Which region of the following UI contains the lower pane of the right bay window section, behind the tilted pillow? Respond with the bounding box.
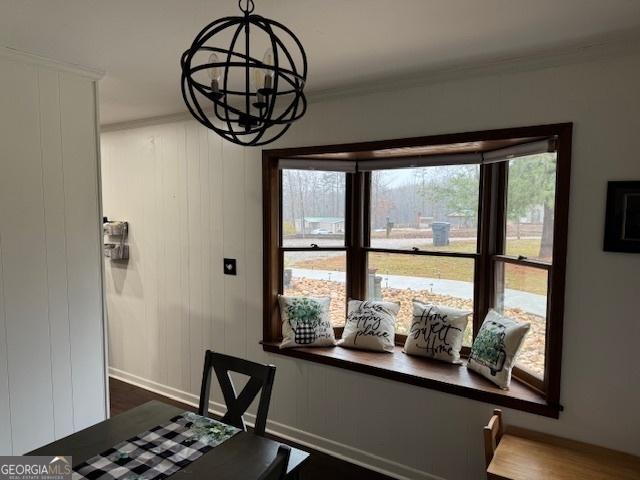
[494,262,548,379]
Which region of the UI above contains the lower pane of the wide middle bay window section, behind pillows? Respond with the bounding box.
[367,253,474,345]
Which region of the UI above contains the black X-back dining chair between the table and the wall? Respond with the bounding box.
[198,350,276,435]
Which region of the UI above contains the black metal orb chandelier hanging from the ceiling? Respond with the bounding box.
[180,0,307,146]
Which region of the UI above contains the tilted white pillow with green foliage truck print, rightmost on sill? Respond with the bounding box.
[467,310,530,390]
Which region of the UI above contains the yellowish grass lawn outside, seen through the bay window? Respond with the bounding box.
[287,240,547,295]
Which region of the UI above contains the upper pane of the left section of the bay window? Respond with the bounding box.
[282,170,346,247]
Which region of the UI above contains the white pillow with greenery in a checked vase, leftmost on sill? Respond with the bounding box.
[278,295,336,348]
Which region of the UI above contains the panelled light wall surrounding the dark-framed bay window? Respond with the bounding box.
[102,49,640,480]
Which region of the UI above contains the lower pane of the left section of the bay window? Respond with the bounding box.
[282,252,347,327]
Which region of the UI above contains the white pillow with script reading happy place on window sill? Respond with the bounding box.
[338,300,400,352]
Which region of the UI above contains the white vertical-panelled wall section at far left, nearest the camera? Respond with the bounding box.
[0,51,106,455]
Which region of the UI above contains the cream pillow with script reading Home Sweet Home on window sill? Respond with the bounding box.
[404,300,471,363]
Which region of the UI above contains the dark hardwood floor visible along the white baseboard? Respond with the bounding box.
[109,378,391,480]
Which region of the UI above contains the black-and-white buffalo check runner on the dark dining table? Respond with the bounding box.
[73,412,240,480]
